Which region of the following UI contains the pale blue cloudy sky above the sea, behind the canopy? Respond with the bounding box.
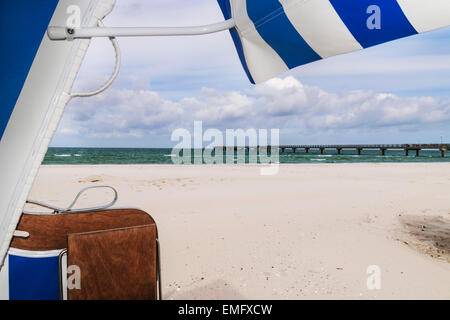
[51,0,450,148]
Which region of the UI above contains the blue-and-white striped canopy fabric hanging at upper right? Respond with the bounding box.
[218,0,450,83]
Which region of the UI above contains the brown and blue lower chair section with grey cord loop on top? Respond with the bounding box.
[6,186,161,300]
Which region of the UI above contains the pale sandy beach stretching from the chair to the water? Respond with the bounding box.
[29,163,450,299]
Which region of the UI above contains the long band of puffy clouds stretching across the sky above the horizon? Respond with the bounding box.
[58,77,450,144]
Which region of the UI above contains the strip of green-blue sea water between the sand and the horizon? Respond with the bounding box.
[43,148,450,165]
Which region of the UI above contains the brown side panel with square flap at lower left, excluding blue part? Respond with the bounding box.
[11,209,161,300]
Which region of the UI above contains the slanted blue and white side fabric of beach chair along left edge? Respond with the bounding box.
[0,0,115,270]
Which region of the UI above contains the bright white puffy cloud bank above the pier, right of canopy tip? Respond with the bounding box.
[250,77,450,130]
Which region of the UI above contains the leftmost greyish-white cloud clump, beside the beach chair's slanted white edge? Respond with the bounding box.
[61,89,185,137]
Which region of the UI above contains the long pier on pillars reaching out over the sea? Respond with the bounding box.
[215,144,450,157]
